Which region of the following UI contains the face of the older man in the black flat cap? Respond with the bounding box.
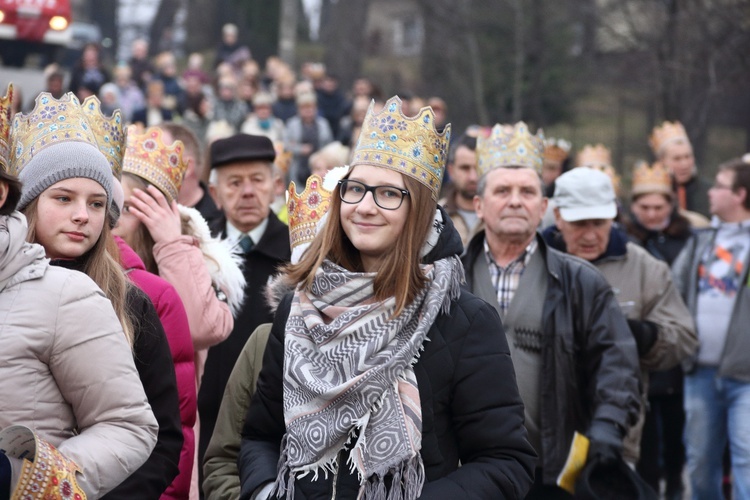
[210,161,274,233]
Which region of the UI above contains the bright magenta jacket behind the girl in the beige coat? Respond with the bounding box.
[115,237,197,499]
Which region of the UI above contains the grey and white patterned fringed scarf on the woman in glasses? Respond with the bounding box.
[276,257,463,500]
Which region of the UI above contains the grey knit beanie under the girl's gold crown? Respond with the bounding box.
[18,141,113,210]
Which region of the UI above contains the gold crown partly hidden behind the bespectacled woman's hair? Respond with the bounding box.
[286,175,332,251]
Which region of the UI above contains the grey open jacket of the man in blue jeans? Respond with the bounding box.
[672,228,750,382]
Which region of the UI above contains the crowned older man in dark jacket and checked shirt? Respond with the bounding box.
[462,122,640,500]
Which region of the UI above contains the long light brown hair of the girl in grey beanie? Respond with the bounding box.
[23,196,135,348]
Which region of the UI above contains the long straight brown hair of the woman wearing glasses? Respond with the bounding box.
[284,167,436,315]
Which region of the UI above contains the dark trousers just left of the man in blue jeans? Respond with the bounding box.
[636,393,685,493]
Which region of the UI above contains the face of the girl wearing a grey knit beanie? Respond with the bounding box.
[34,177,107,259]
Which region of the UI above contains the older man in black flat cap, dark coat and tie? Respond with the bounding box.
[198,134,291,480]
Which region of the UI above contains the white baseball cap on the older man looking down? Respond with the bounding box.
[552,167,617,222]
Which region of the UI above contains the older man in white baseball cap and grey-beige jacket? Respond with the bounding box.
[543,167,698,472]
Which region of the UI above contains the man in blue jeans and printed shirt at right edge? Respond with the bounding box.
[672,154,750,498]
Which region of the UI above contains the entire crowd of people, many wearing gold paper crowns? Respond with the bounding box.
[0,30,750,500]
